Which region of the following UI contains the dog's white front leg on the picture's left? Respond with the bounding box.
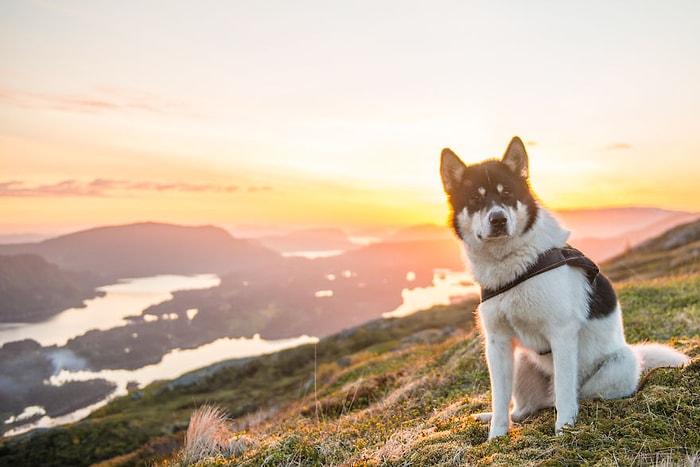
[486,335,513,439]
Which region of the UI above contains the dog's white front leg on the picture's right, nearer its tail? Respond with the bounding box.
[551,331,578,434]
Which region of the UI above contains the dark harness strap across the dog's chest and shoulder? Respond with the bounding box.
[481,245,600,302]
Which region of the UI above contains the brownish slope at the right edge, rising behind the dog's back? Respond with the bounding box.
[601,220,700,281]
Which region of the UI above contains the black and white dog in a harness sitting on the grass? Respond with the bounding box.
[440,136,690,439]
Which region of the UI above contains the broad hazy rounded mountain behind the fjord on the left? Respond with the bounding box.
[0,222,279,282]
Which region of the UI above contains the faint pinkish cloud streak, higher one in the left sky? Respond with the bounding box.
[0,87,200,116]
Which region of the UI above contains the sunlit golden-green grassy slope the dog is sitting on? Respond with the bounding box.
[164,276,700,466]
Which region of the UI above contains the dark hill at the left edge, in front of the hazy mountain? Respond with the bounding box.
[0,254,100,323]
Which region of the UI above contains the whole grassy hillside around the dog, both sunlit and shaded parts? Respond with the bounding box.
[0,275,700,466]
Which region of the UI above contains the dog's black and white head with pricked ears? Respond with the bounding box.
[440,136,537,244]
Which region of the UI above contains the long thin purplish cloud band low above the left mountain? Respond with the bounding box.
[0,178,272,198]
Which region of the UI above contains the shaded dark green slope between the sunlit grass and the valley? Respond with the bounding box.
[0,305,473,466]
